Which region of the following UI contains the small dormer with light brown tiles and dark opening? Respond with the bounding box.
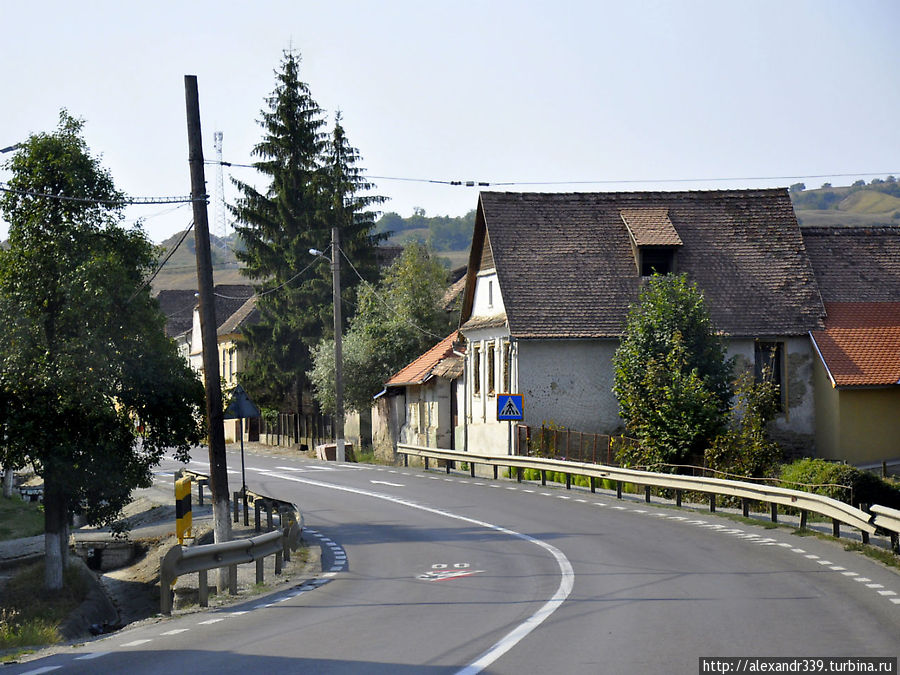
[619,206,683,277]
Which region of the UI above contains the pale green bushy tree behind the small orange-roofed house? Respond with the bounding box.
[309,243,455,412]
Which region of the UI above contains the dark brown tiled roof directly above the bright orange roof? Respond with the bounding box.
[800,226,900,302]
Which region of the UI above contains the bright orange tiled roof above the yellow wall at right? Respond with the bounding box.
[812,302,900,387]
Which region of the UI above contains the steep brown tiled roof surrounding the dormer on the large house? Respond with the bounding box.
[461,189,824,338]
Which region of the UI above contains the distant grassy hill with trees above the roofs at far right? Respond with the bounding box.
[790,176,900,227]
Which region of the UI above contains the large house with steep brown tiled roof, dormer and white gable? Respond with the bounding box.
[460,189,825,454]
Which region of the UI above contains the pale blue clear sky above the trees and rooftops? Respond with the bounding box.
[0,0,900,242]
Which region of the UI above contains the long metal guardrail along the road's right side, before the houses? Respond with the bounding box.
[397,443,900,551]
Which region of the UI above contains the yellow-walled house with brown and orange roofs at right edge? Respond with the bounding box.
[803,226,900,465]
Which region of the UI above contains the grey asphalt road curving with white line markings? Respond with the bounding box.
[8,452,900,675]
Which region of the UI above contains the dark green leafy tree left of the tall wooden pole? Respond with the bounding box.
[0,111,203,588]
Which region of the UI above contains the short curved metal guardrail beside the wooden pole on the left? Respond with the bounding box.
[159,470,303,614]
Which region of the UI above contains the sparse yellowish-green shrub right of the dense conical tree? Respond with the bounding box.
[704,372,781,478]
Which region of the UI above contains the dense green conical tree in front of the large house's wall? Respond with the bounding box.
[613,275,733,466]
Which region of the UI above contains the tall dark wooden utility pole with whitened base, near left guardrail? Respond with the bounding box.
[184,75,231,593]
